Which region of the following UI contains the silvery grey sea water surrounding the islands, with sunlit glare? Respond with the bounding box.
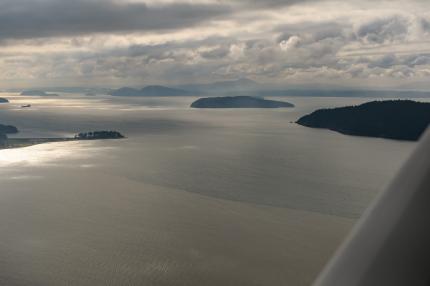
[0,94,424,285]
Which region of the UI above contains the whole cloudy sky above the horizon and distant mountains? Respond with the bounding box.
[0,0,430,90]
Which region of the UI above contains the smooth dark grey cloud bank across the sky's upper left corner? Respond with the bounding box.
[0,0,231,39]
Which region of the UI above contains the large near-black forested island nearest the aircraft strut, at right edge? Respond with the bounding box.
[297,100,430,141]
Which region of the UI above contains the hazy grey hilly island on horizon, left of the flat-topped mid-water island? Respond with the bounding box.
[110,85,191,96]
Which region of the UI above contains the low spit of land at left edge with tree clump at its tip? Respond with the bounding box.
[0,127,125,149]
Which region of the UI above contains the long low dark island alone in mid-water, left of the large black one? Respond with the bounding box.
[191,96,294,108]
